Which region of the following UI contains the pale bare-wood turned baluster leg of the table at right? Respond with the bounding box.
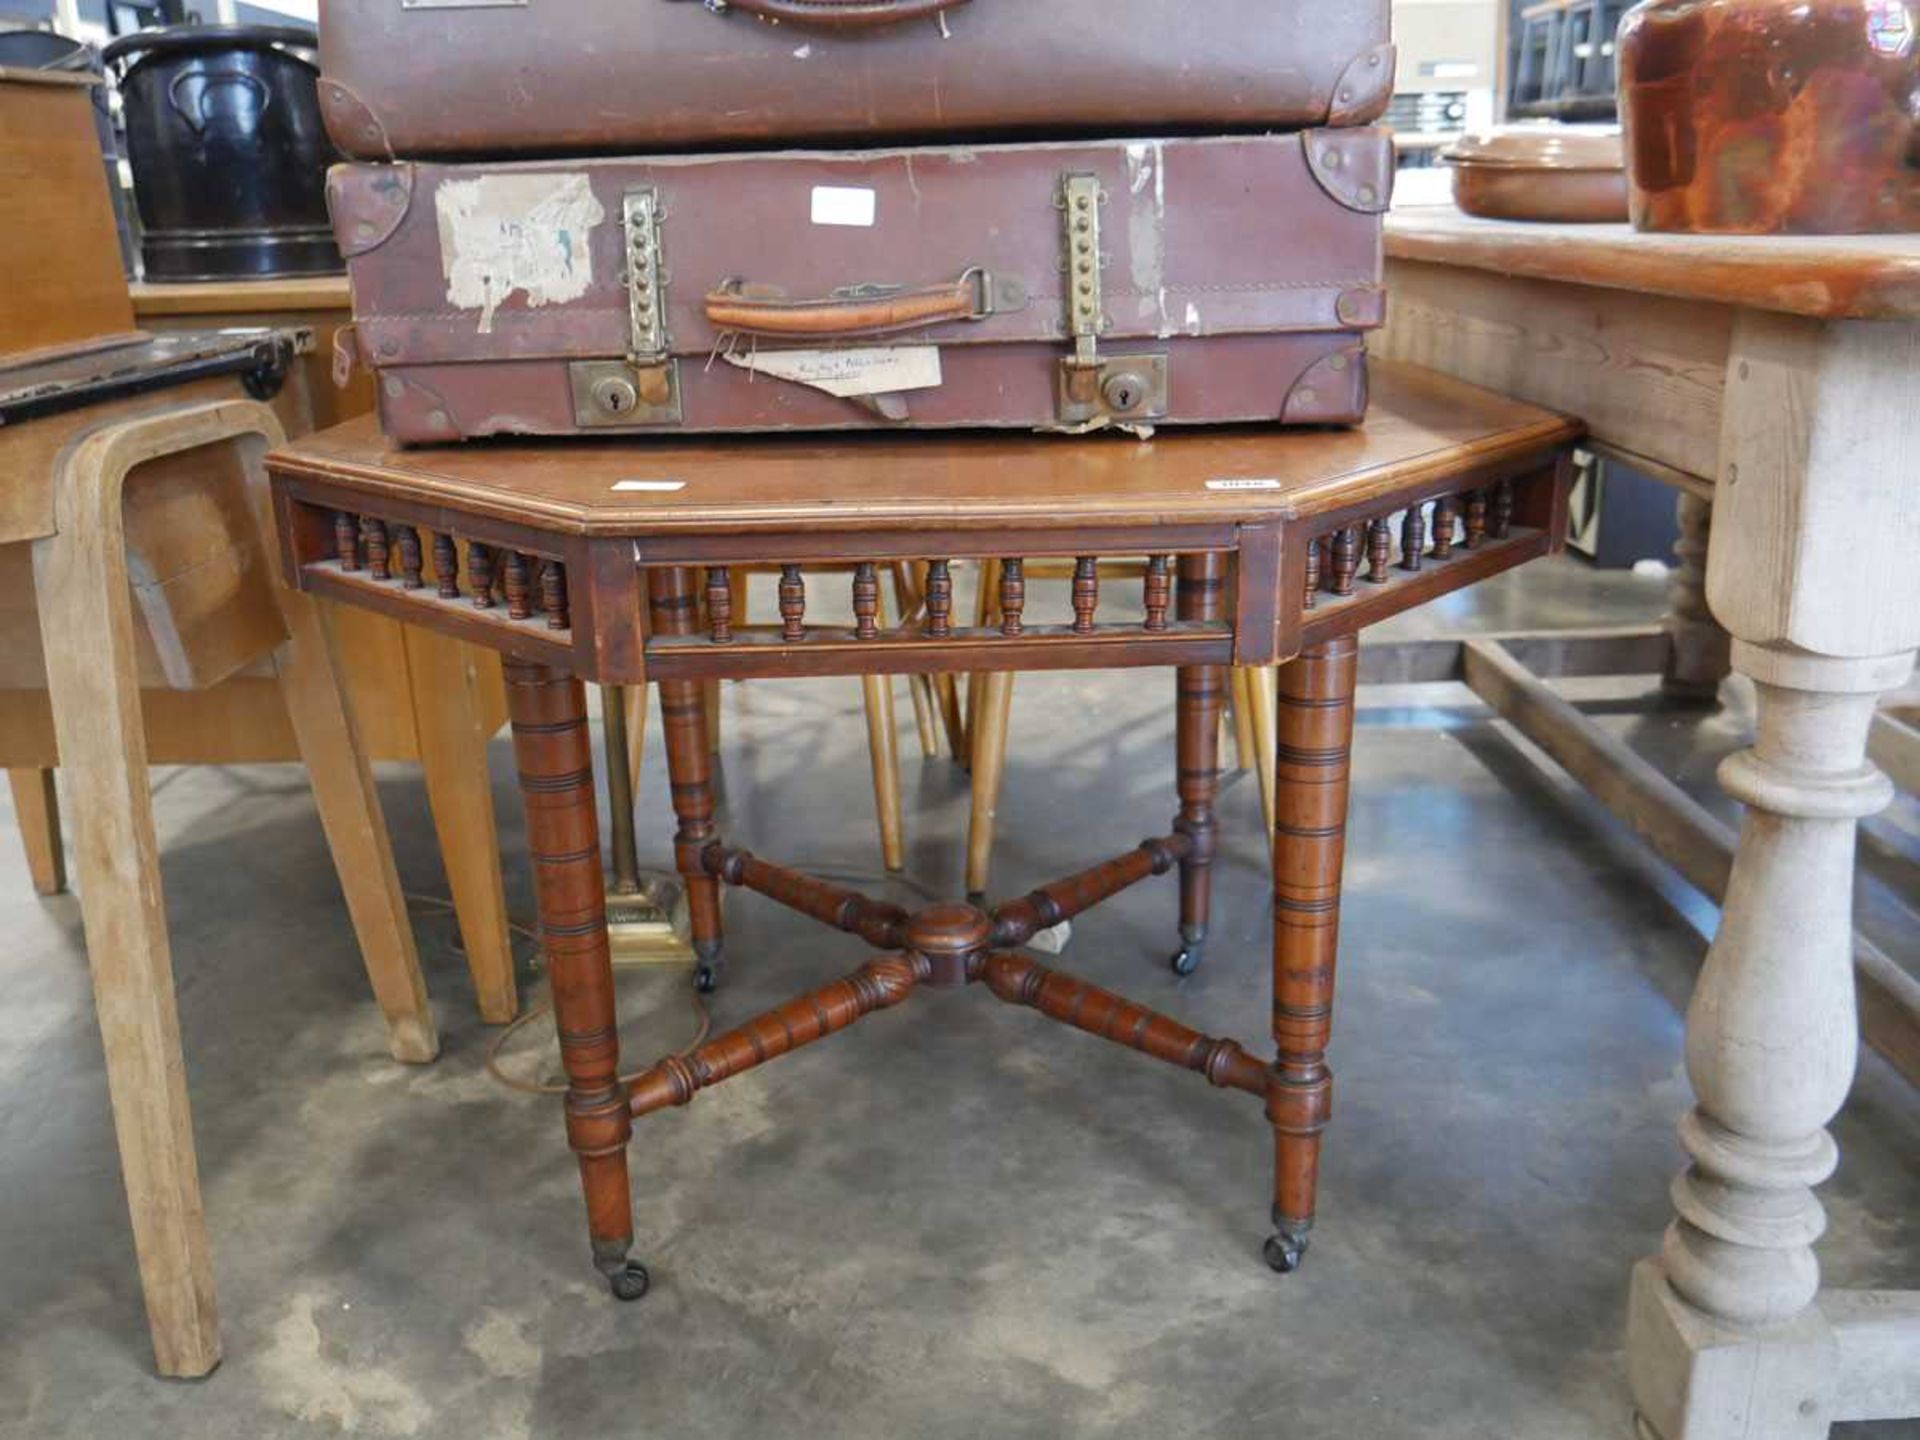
[1626,313,1920,1440]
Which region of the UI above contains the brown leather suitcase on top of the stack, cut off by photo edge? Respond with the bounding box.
[321,0,1394,159]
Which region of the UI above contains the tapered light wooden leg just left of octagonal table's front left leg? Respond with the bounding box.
[405,626,520,1025]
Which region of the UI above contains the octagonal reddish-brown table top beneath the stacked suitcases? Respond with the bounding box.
[269,363,1580,536]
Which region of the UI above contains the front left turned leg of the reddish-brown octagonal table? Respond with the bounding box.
[507,660,648,1300]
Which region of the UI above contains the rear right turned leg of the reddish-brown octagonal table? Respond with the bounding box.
[1171,555,1229,975]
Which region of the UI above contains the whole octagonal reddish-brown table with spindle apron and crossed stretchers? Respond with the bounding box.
[271,366,1578,1298]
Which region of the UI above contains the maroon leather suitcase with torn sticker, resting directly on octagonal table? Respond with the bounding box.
[328,129,1394,442]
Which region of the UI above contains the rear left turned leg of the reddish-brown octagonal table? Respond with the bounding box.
[651,570,722,991]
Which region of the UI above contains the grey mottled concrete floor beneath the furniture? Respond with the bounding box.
[0,561,1920,1440]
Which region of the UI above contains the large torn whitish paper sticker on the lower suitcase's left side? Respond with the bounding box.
[434,175,607,334]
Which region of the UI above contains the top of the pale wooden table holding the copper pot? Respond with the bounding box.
[1386,204,1920,321]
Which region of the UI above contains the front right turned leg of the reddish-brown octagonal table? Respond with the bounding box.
[1267,637,1359,1273]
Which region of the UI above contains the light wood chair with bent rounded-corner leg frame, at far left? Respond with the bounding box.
[0,399,440,1377]
